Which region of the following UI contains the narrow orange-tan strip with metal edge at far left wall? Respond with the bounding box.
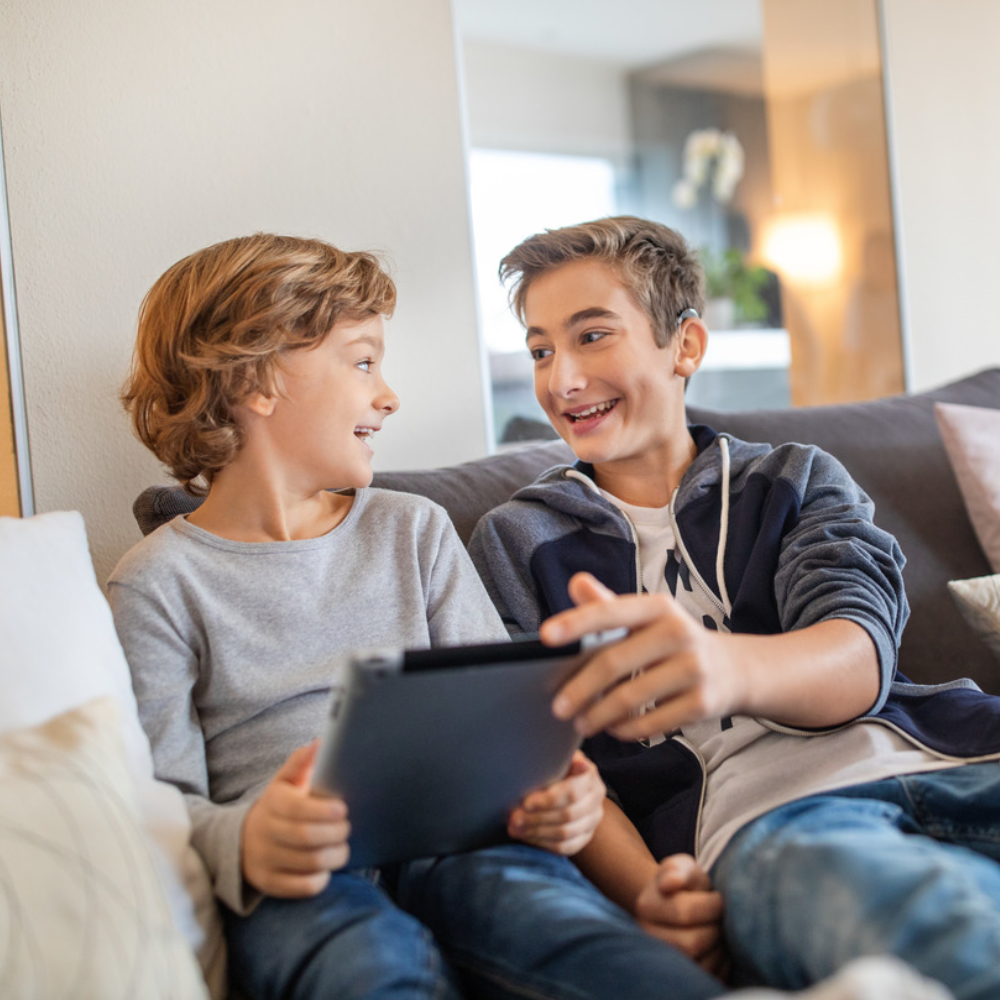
[0,119,34,517]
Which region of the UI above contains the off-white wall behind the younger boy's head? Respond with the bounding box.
[0,0,486,580]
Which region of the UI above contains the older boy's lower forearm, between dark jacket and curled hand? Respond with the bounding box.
[573,799,657,914]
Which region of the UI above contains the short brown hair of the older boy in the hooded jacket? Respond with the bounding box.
[500,215,705,347]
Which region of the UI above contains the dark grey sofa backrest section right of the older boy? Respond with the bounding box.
[690,368,1000,694]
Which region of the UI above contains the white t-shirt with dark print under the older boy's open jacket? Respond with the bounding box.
[601,490,961,868]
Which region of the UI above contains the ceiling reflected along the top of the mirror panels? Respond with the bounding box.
[452,0,881,96]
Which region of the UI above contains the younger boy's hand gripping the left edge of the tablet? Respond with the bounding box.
[242,741,351,899]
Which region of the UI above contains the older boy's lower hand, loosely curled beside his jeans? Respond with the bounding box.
[635,854,729,978]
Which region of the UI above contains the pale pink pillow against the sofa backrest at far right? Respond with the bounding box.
[928,403,1000,573]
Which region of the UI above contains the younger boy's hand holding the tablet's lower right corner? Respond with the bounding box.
[507,750,605,857]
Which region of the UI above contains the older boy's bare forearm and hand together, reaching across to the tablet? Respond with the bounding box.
[541,573,881,740]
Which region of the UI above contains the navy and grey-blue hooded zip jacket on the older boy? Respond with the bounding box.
[469,426,1000,858]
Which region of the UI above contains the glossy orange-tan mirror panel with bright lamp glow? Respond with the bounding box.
[757,0,904,405]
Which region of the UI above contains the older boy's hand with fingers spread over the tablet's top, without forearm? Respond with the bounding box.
[540,573,743,740]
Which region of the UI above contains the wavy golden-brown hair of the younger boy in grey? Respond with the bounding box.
[121,233,396,494]
